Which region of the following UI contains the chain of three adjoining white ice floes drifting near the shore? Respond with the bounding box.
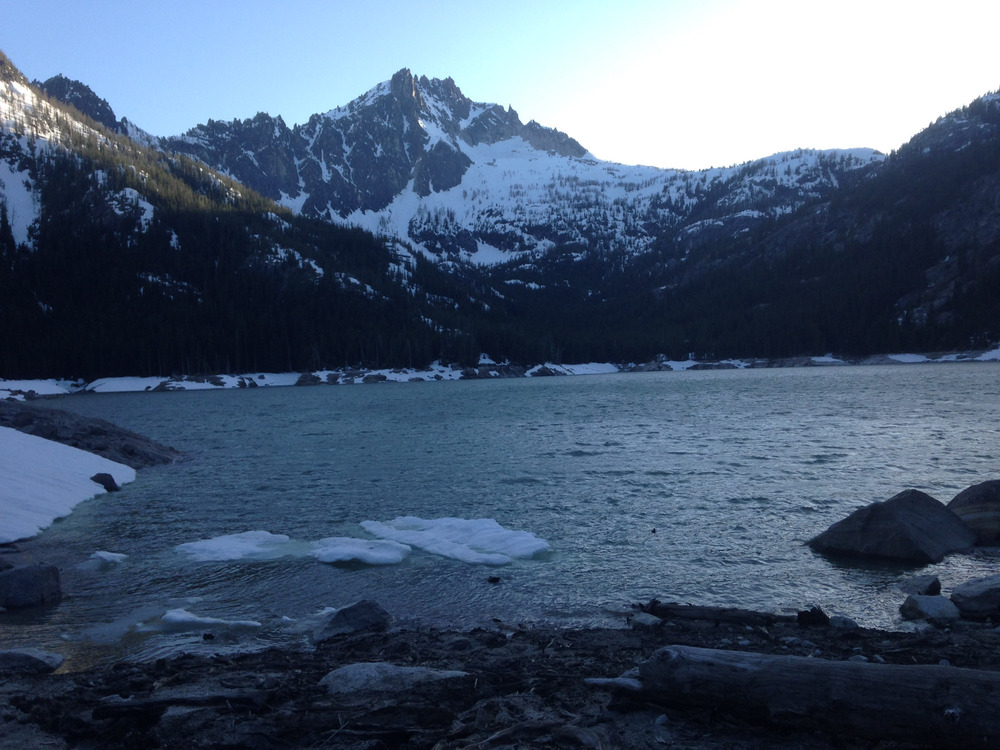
[176,516,549,565]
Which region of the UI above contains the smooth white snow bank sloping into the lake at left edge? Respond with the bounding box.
[0,427,135,544]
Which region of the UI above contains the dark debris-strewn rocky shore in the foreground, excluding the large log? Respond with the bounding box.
[0,602,1000,750]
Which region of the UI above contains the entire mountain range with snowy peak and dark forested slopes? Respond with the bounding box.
[0,51,1000,377]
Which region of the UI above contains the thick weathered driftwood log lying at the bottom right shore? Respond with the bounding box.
[639,646,1000,748]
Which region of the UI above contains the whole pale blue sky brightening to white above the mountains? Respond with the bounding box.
[0,0,1000,169]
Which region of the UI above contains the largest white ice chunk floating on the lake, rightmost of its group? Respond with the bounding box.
[361,516,549,565]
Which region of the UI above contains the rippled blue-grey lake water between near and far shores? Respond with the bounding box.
[7,364,1000,665]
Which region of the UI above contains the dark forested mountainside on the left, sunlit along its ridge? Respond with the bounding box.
[0,51,480,378]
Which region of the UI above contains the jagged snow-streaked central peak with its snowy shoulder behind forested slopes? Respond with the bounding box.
[163,69,883,264]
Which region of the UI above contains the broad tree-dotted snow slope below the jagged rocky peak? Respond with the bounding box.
[344,138,882,264]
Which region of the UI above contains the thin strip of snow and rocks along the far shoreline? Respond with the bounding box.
[0,347,1000,400]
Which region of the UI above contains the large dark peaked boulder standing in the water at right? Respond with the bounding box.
[809,490,976,564]
